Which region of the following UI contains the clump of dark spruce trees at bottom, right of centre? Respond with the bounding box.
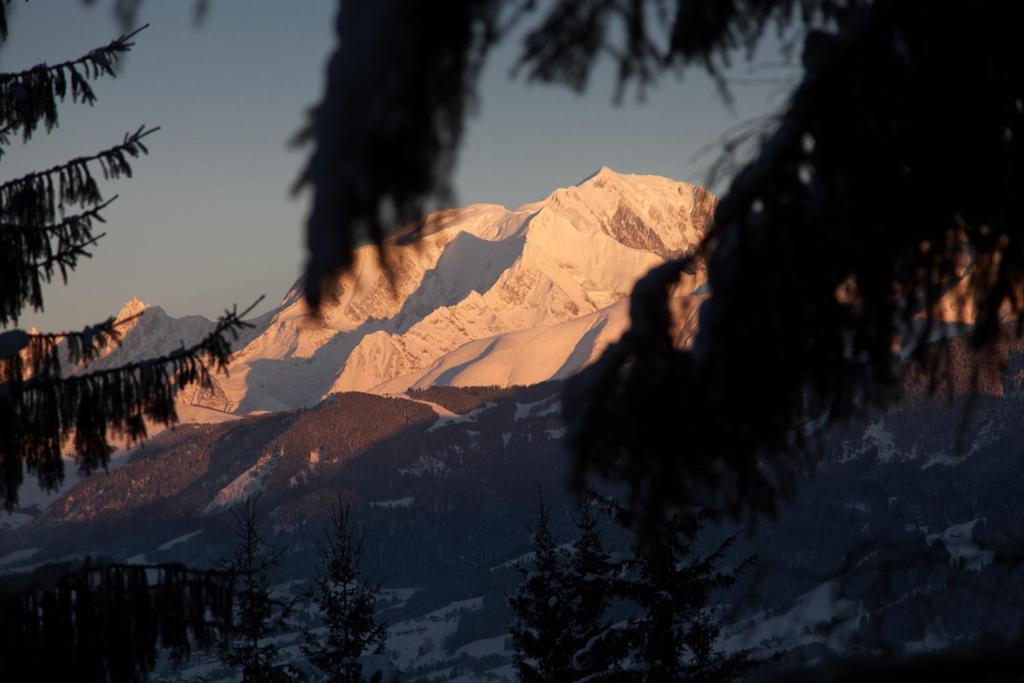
[509,494,754,683]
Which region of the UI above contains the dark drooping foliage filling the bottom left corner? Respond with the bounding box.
[0,562,234,682]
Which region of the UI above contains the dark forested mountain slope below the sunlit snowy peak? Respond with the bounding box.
[0,385,1024,680]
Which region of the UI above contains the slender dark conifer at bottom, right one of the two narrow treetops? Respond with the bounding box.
[302,501,387,683]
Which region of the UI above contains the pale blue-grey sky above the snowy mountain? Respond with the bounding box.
[0,0,781,330]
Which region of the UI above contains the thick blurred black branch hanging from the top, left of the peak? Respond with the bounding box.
[296,0,503,309]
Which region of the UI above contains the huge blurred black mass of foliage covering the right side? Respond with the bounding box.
[567,2,1024,524]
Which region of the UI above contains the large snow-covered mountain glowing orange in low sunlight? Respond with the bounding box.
[192,168,715,413]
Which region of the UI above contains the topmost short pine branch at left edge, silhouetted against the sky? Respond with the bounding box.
[0,24,148,140]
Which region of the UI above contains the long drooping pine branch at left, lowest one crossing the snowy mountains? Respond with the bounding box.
[0,297,262,509]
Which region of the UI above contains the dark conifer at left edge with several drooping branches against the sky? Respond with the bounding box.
[0,12,256,510]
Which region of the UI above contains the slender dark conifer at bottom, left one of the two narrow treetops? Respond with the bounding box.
[218,500,302,683]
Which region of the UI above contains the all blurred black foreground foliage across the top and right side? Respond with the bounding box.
[292,0,1024,519]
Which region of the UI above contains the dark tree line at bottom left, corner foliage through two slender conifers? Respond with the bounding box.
[0,500,397,683]
